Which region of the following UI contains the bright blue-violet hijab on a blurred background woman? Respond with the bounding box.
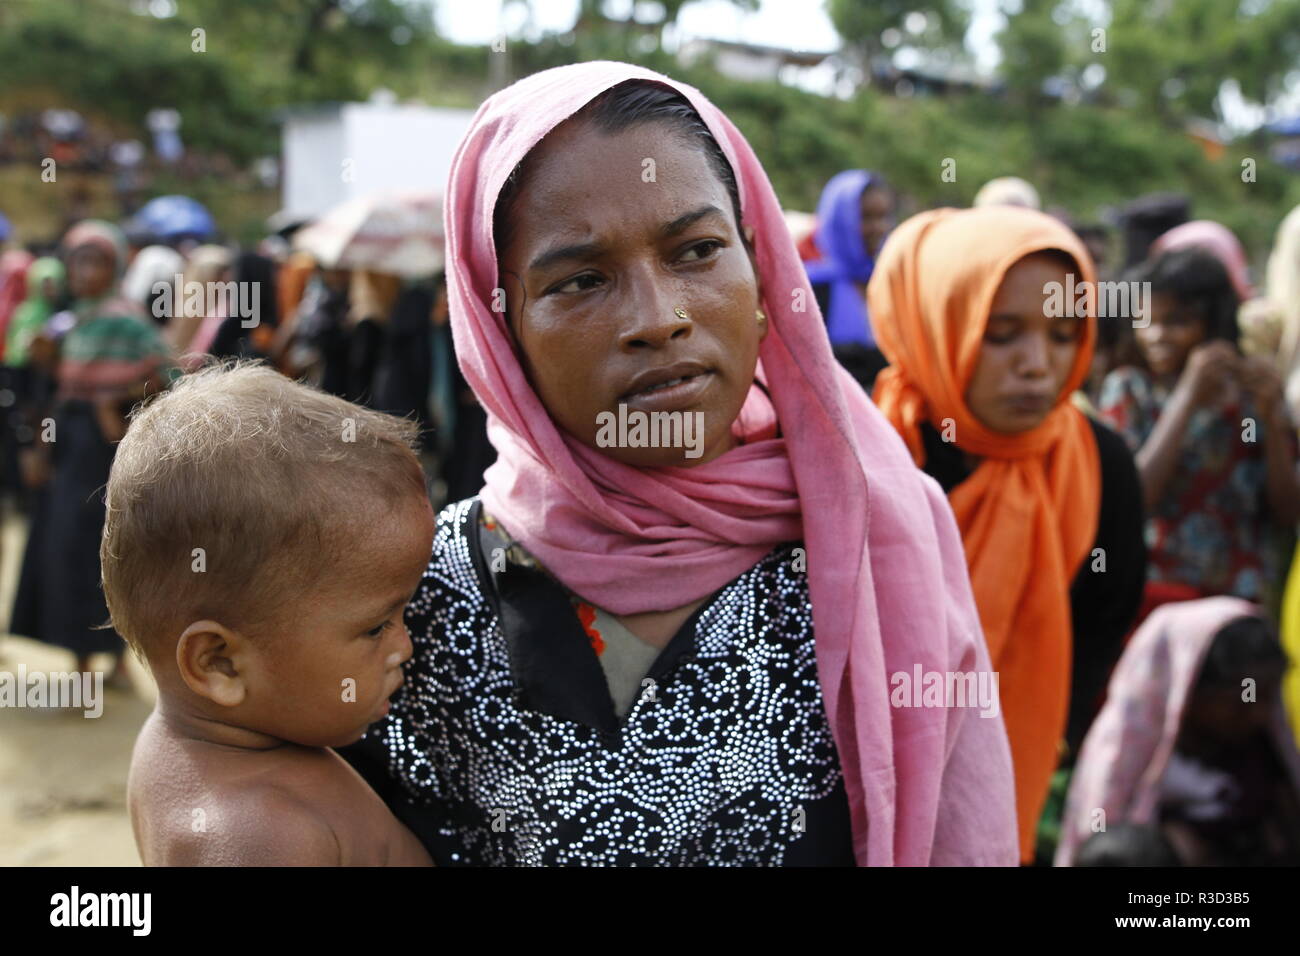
[805,169,880,347]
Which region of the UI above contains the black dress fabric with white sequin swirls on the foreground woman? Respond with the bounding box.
[368,499,842,866]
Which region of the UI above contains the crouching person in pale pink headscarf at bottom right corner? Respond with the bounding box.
[1056,597,1300,866]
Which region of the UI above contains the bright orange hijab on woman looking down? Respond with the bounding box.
[867,207,1101,861]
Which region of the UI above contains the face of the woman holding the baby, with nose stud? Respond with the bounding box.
[501,120,767,467]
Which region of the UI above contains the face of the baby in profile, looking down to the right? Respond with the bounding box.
[239,496,434,747]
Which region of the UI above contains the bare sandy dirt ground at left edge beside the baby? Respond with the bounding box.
[0,515,155,866]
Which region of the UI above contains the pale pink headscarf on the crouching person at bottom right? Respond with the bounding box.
[1056,597,1300,866]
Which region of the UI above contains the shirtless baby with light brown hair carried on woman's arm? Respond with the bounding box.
[100,363,434,866]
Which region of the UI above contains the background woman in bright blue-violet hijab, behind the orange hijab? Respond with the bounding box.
[805,169,894,390]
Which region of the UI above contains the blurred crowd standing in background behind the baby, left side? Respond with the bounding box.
[0,220,494,688]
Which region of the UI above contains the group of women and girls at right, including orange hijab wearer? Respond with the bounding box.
[800,170,1300,865]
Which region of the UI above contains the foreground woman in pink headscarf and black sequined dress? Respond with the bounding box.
[345,62,1017,865]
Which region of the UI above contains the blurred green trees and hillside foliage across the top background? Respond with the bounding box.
[0,0,1300,261]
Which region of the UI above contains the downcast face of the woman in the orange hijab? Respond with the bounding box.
[966,254,1084,434]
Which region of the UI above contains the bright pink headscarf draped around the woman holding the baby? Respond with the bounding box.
[445,62,1017,865]
